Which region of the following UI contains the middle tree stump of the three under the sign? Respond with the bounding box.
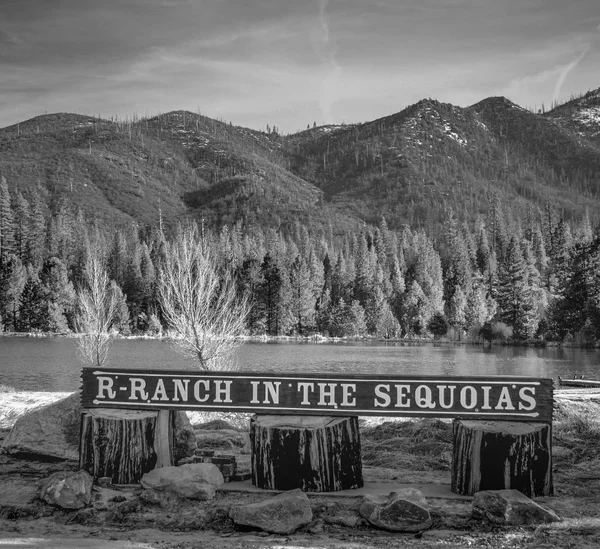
[250,415,363,492]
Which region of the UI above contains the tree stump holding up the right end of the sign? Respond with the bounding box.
[451,419,553,497]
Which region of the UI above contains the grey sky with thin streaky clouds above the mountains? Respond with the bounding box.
[0,0,600,133]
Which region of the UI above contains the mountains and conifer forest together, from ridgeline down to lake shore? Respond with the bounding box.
[0,88,600,344]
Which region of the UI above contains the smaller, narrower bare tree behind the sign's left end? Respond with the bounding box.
[75,244,117,368]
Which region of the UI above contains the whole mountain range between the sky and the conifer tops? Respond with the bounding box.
[0,89,600,234]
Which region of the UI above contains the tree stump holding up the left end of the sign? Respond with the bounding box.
[79,409,174,484]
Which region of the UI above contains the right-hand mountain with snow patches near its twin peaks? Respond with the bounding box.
[288,92,600,228]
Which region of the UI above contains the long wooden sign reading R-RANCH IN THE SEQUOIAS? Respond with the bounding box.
[82,368,553,422]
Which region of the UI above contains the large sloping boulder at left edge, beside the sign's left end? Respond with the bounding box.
[2,392,81,460]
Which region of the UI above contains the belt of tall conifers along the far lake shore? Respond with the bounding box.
[0,178,600,344]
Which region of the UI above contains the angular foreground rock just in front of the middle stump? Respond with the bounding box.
[229,489,313,534]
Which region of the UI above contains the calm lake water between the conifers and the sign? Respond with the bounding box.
[0,337,600,391]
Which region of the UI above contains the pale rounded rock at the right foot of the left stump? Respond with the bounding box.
[140,463,223,500]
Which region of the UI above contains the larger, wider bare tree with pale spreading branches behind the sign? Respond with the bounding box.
[158,225,249,370]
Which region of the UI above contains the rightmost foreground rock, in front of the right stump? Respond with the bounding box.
[473,490,560,526]
